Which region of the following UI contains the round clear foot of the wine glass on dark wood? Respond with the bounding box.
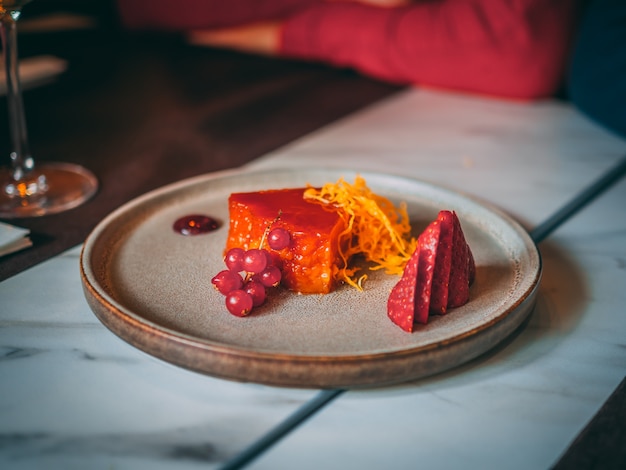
[0,163,98,219]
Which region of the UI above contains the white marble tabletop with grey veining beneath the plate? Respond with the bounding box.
[0,90,626,469]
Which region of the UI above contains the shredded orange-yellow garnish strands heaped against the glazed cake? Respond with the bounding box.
[304,175,417,290]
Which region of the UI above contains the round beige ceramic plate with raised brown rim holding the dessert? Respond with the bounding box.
[81,169,541,387]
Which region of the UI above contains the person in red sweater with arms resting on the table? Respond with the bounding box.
[118,0,576,100]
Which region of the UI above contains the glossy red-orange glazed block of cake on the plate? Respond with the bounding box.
[226,188,346,294]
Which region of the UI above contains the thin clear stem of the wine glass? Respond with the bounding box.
[0,10,34,181]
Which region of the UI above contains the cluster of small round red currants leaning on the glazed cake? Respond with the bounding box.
[211,227,291,317]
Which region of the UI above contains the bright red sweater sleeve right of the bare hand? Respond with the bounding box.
[281,0,574,99]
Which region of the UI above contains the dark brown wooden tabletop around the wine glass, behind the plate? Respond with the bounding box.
[0,0,399,280]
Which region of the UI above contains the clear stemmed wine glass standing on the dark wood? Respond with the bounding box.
[0,0,98,218]
